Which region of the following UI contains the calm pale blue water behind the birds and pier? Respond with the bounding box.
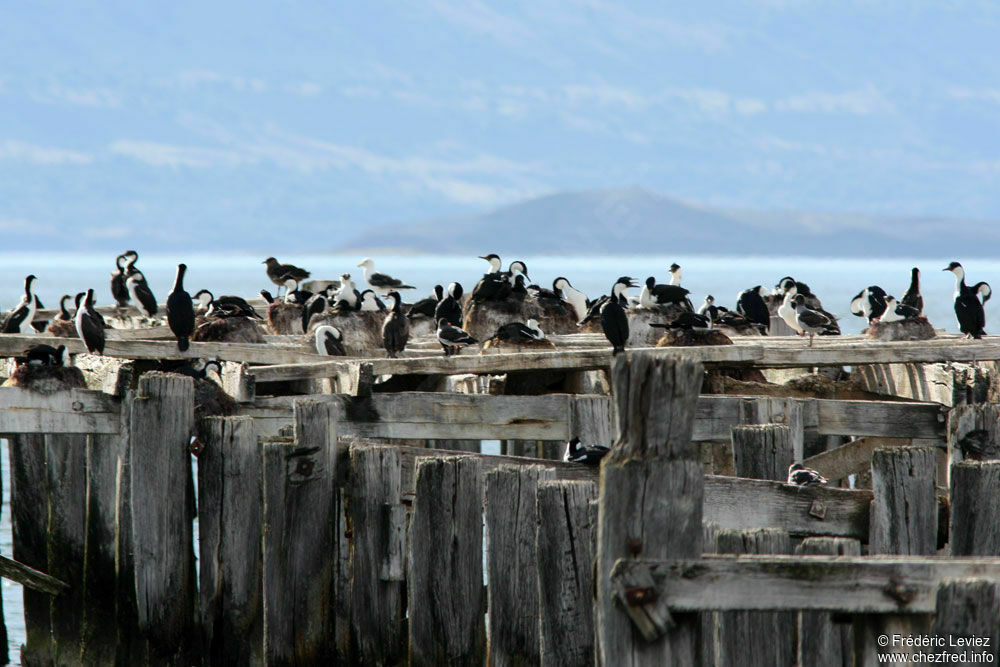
[0,253,1000,661]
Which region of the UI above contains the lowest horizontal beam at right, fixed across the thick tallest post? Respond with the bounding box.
[612,555,1000,614]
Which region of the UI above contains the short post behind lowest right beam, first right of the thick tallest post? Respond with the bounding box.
[716,528,796,667]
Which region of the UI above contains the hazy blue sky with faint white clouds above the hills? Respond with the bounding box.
[0,0,1000,251]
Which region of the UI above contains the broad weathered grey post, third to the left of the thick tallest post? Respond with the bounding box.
[408,456,486,666]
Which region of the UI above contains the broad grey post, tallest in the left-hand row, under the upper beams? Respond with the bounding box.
[129,372,195,662]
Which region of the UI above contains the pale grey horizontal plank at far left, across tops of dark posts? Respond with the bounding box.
[0,388,121,434]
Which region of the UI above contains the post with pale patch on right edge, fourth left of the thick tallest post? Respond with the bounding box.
[349,446,406,665]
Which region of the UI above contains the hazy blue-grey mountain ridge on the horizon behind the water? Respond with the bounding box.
[337,188,1000,257]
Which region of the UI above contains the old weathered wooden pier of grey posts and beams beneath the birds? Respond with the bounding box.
[0,329,1000,665]
